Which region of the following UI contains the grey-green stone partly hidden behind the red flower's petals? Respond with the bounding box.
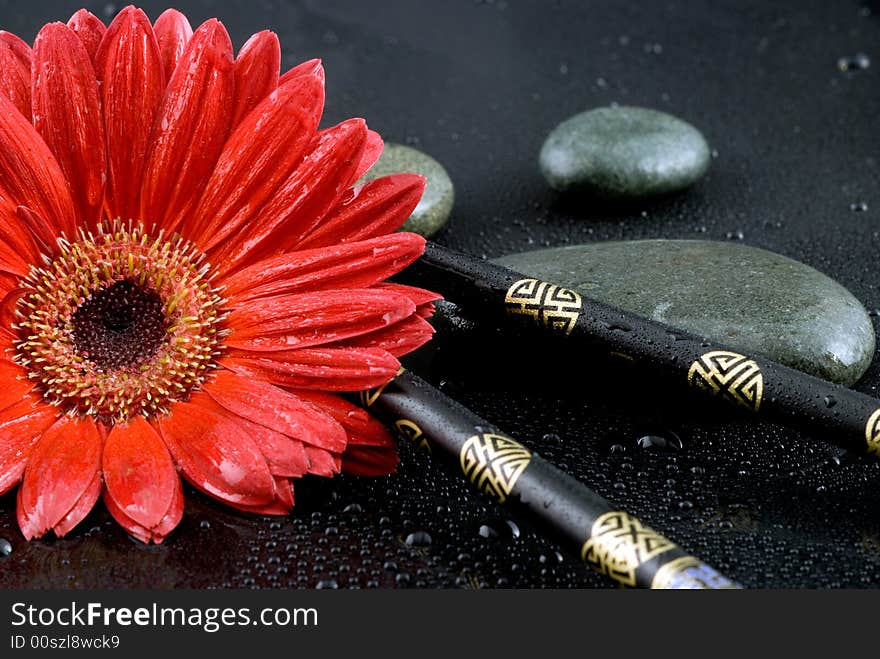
[360,142,455,238]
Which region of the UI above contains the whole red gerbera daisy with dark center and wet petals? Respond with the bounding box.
[0,7,436,542]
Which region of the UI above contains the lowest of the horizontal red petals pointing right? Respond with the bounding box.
[223,347,400,391]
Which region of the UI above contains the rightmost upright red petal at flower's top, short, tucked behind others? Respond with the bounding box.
[232,30,281,126]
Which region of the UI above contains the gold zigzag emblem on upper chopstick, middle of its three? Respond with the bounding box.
[688,350,764,412]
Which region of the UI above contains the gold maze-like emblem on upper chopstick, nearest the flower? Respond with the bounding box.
[504,279,583,334]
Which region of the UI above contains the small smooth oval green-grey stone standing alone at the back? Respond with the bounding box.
[539,107,711,199]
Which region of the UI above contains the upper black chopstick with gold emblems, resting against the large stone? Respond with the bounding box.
[400,242,880,456]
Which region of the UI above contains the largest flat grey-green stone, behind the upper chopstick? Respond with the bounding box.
[495,240,874,385]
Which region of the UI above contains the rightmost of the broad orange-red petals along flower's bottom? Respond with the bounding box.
[158,394,275,506]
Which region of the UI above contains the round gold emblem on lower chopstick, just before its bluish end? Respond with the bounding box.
[581,511,676,586]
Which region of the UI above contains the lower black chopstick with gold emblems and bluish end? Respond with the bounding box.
[359,369,739,589]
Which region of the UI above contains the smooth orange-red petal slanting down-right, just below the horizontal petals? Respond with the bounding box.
[205,371,345,451]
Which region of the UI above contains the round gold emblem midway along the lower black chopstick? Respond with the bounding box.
[459,433,532,503]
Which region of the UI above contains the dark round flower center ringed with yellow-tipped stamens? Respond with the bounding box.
[15,223,224,423]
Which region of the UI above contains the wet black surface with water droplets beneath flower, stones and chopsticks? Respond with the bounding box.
[0,0,880,588]
